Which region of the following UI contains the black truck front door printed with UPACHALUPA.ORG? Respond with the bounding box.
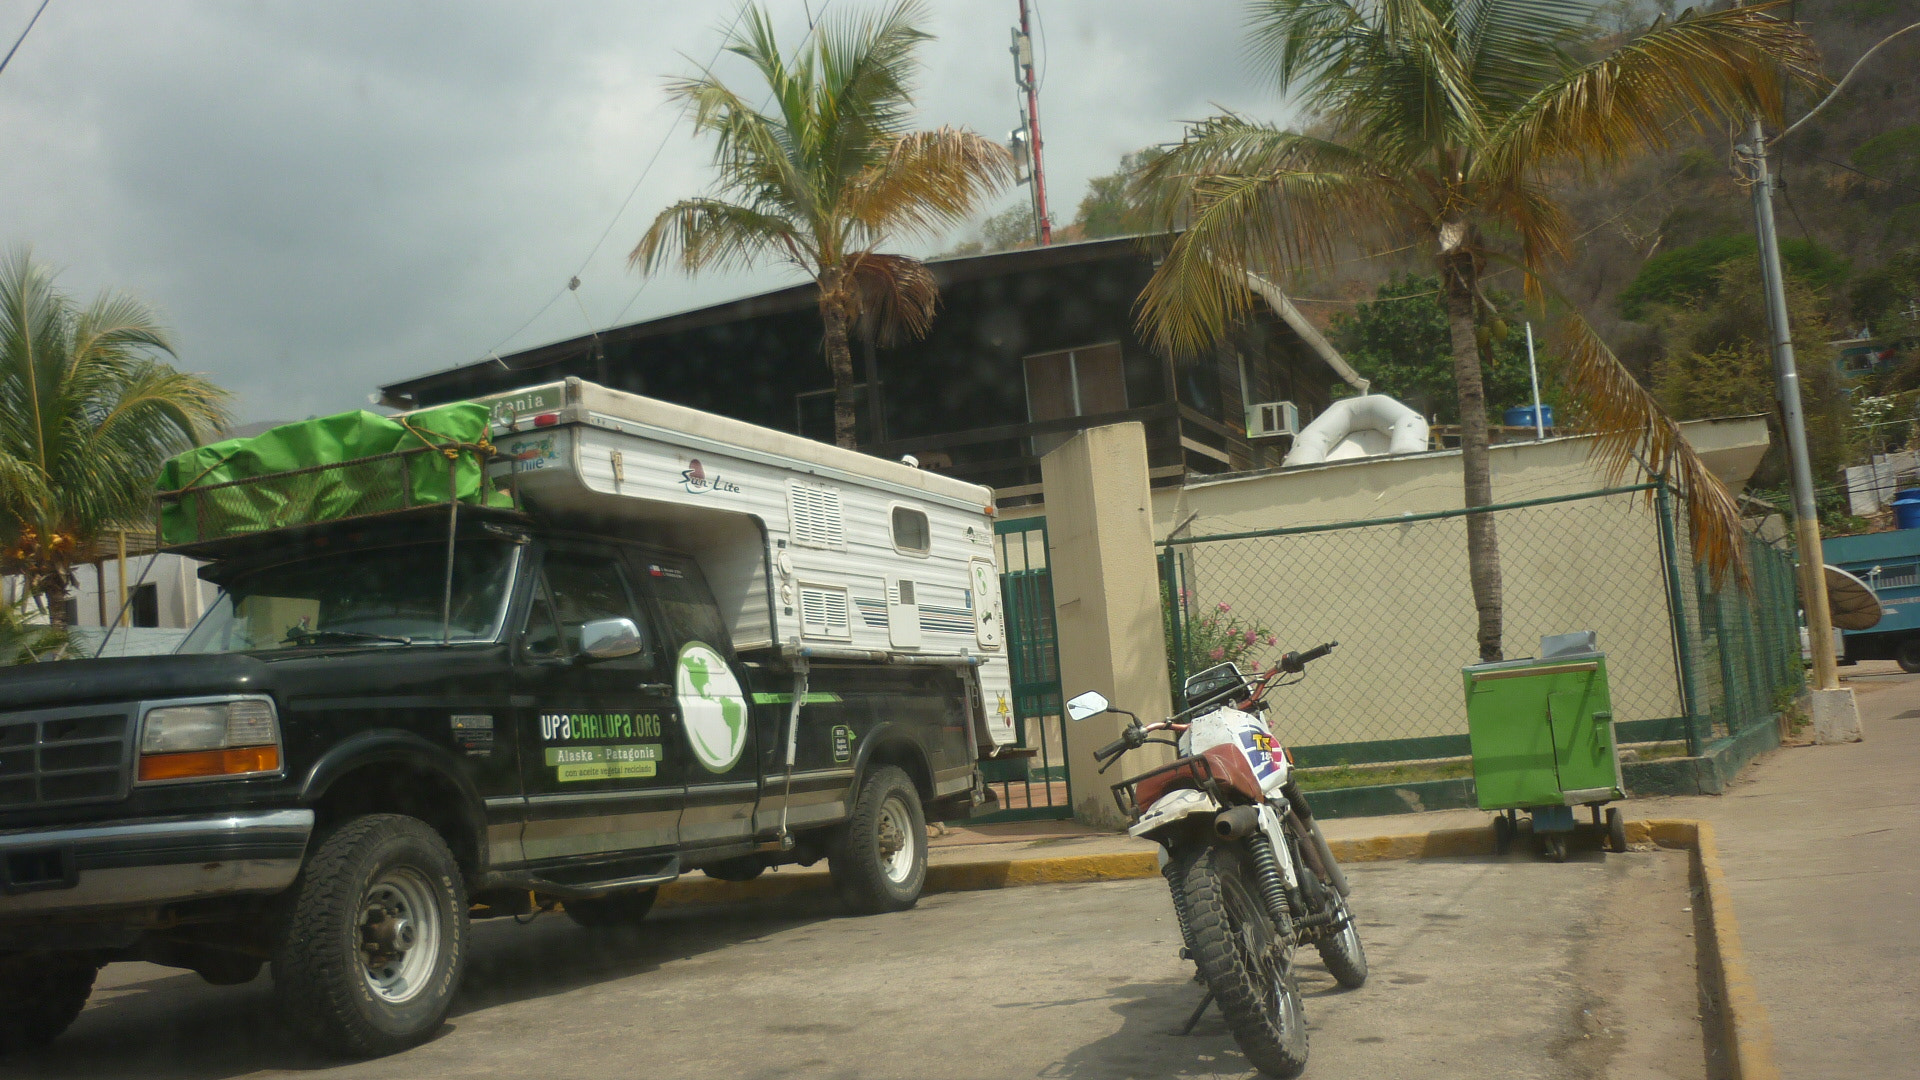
[515,544,685,863]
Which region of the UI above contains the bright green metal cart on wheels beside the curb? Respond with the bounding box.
[1461,630,1626,863]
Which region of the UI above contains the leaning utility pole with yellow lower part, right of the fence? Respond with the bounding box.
[1741,117,1860,742]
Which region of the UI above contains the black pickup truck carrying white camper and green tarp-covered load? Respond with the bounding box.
[0,380,1014,1055]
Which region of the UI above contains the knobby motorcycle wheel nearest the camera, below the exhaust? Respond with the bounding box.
[1167,844,1308,1080]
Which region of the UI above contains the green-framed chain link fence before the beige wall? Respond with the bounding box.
[1162,484,1801,767]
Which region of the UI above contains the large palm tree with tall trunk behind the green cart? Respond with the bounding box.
[1140,0,1818,661]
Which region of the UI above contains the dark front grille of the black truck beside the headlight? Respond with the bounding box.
[0,707,132,811]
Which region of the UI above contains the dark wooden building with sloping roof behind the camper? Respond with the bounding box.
[382,238,1359,505]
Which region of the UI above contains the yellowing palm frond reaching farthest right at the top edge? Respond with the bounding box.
[1480,2,1822,179]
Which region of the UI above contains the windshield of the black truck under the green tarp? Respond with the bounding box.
[179,538,518,653]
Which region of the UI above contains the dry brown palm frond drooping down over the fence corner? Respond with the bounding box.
[1559,313,1751,586]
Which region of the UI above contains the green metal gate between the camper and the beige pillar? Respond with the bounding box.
[973,517,1073,822]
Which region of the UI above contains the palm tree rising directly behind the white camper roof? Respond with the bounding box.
[628,0,1014,448]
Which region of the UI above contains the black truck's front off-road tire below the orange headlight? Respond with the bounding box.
[273,813,467,1057]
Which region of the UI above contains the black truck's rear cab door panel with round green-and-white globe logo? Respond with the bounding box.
[630,552,760,847]
